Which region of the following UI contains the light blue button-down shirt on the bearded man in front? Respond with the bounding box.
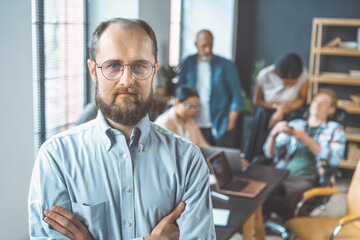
[29,111,215,240]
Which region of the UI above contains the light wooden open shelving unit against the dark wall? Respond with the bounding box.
[307,18,360,169]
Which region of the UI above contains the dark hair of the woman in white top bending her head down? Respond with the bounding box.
[275,53,303,79]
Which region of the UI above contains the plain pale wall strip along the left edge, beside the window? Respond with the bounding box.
[0,0,34,240]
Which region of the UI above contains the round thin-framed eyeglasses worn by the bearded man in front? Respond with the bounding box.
[94,60,155,81]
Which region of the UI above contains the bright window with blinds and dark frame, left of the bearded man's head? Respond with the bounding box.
[32,0,88,150]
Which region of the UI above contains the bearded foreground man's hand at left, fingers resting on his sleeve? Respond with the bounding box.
[44,205,93,240]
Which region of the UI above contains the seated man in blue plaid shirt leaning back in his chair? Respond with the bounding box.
[264,88,346,219]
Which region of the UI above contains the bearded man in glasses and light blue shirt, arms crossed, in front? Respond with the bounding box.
[29,18,215,239]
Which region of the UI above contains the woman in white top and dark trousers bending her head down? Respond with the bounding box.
[245,53,308,159]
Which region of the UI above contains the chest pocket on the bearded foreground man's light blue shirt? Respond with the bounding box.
[71,202,111,240]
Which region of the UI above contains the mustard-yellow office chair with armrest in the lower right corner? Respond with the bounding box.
[285,159,360,240]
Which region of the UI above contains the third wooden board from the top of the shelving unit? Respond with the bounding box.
[309,72,360,86]
